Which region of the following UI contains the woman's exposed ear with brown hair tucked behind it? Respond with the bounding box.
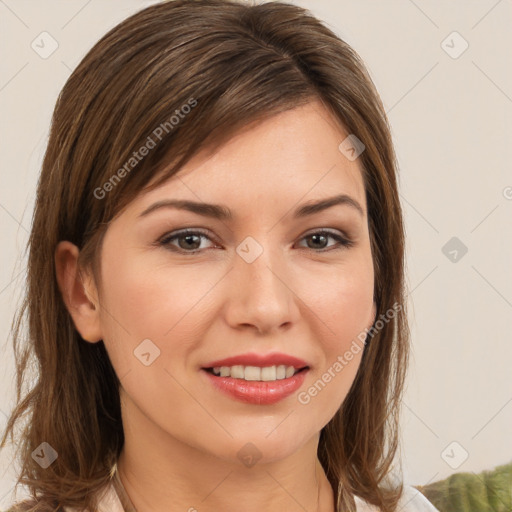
[55,241,103,343]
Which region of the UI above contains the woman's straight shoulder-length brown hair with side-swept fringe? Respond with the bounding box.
[2,0,409,512]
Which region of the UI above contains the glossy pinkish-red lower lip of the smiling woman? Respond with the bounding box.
[202,370,309,405]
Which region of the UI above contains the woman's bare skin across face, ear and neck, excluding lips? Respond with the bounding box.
[56,101,375,512]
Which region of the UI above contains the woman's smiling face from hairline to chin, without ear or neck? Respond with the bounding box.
[84,102,375,461]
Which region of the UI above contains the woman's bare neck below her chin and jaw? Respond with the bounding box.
[117,390,335,512]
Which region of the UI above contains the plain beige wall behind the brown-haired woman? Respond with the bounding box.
[0,0,512,508]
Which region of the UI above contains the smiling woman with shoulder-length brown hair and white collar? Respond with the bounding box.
[3,0,435,512]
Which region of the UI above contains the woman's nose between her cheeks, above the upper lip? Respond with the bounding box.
[225,241,300,334]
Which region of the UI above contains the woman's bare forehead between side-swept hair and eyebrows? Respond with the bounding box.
[130,101,366,218]
